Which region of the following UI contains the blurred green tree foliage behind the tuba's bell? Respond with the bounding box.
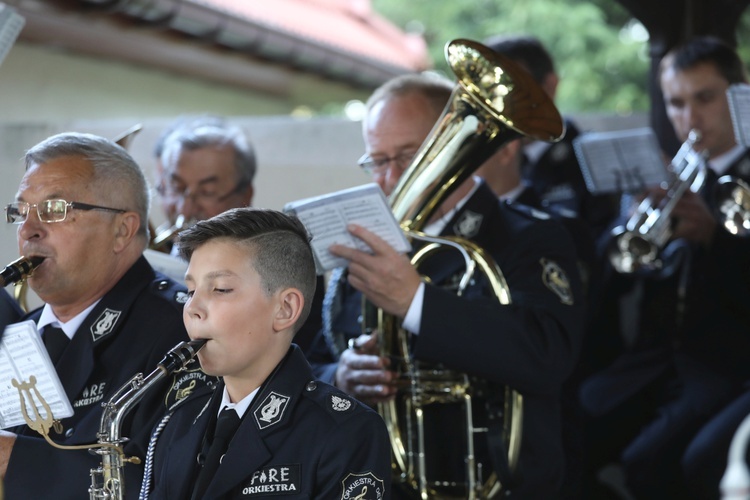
[373,0,649,115]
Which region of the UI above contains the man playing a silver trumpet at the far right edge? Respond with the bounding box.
[582,38,750,498]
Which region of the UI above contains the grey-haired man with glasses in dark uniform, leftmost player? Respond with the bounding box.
[0,133,187,500]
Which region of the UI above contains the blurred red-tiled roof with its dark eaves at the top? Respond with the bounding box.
[11,0,430,88]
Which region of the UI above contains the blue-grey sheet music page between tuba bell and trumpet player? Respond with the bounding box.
[573,128,668,194]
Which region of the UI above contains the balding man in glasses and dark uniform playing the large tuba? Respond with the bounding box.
[309,75,583,499]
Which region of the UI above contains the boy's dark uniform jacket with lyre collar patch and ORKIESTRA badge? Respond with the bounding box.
[148,344,390,500]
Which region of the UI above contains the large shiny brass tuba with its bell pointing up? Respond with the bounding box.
[370,40,564,499]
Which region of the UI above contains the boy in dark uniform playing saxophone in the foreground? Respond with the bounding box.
[142,208,391,500]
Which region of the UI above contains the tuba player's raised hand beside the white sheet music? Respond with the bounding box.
[330,224,421,318]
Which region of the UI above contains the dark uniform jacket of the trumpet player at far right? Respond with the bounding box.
[586,151,750,414]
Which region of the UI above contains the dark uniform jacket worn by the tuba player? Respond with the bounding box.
[310,184,584,498]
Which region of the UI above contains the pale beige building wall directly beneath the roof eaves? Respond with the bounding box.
[0,42,368,122]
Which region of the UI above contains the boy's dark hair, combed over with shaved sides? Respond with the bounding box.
[176,207,316,333]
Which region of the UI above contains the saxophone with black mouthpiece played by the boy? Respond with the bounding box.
[89,340,206,500]
